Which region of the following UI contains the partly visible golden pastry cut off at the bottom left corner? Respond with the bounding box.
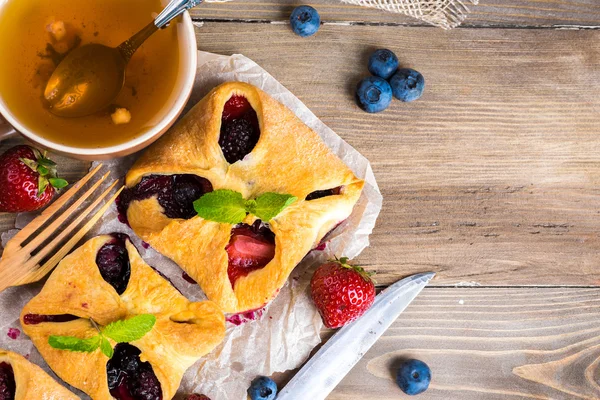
[0,349,79,400]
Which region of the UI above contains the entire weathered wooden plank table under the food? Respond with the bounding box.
[0,0,600,400]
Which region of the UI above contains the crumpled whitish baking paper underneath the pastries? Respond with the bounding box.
[0,52,382,400]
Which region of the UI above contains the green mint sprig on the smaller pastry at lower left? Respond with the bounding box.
[48,314,156,358]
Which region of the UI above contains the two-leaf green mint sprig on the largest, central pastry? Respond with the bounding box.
[194,189,298,224]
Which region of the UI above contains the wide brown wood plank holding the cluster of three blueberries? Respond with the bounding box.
[198,23,600,285]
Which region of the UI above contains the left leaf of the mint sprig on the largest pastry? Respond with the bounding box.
[194,189,246,224]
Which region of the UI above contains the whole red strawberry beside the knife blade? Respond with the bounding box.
[310,257,375,329]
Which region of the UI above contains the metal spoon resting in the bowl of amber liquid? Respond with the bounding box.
[44,0,203,117]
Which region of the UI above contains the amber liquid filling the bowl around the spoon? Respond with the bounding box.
[0,0,179,148]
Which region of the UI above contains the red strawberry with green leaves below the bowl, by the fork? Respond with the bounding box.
[0,145,68,212]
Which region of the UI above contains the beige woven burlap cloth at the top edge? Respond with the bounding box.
[205,0,479,29]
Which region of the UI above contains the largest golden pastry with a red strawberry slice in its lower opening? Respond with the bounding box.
[118,82,364,313]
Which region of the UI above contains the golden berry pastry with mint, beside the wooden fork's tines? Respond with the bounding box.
[21,234,225,400]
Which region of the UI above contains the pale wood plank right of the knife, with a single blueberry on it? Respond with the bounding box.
[328,288,600,400]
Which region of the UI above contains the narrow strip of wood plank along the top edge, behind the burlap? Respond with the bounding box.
[192,0,600,27]
